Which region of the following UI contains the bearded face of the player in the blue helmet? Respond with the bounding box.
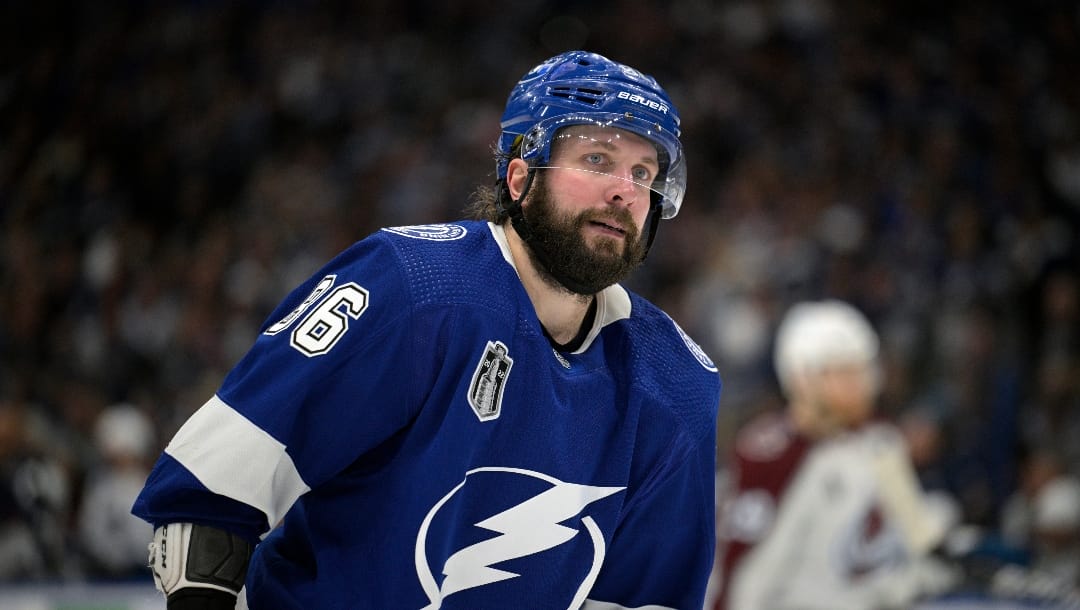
[524,125,659,293]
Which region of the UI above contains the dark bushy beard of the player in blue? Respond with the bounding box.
[526,174,645,296]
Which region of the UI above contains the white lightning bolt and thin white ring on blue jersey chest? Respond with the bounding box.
[416,467,625,610]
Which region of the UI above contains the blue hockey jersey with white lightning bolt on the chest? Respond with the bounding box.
[134,221,719,610]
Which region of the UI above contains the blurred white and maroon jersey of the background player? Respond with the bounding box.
[716,416,943,610]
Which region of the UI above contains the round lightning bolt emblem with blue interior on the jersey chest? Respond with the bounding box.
[416,466,625,610]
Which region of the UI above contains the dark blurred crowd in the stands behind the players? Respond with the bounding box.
[0,0,1080,582]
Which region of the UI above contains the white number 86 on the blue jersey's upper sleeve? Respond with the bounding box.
[266,275,367,357]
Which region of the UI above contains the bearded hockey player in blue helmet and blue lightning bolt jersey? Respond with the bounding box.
[134,52,719,610]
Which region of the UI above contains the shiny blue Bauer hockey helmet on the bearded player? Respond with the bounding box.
[496,51,686,218]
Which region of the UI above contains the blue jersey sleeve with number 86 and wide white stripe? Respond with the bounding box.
[133,233,425,540]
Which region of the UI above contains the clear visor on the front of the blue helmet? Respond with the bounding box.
[521,114,686,218]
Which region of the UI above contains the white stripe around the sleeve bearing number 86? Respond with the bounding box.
[165,394,310,528]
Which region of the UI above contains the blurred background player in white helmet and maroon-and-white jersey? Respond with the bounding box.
[715,301,956,610]
